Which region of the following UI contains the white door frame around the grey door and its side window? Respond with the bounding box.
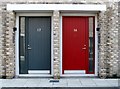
[15,12,53,77]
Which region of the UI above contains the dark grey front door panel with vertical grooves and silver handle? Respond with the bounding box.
[26,17,51,70]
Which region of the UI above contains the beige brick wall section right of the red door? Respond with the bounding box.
[99,3,118,77]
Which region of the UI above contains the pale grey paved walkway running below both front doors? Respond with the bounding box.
[0,78,120,87]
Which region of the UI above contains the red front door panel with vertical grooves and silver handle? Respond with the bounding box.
[62,16,89,74]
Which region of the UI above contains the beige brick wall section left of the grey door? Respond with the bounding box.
[0,3,15,78]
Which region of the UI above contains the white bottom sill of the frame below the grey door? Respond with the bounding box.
[18,74,53,77]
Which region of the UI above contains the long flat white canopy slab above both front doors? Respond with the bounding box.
[7,4,106,11]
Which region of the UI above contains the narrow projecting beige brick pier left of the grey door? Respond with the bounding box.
[5,11,15,78]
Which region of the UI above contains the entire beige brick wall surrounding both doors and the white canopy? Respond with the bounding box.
[0,0,120,78]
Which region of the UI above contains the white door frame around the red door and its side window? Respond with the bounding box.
[60,13,98,77]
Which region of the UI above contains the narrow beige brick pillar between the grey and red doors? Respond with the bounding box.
[53,11,60,78]
